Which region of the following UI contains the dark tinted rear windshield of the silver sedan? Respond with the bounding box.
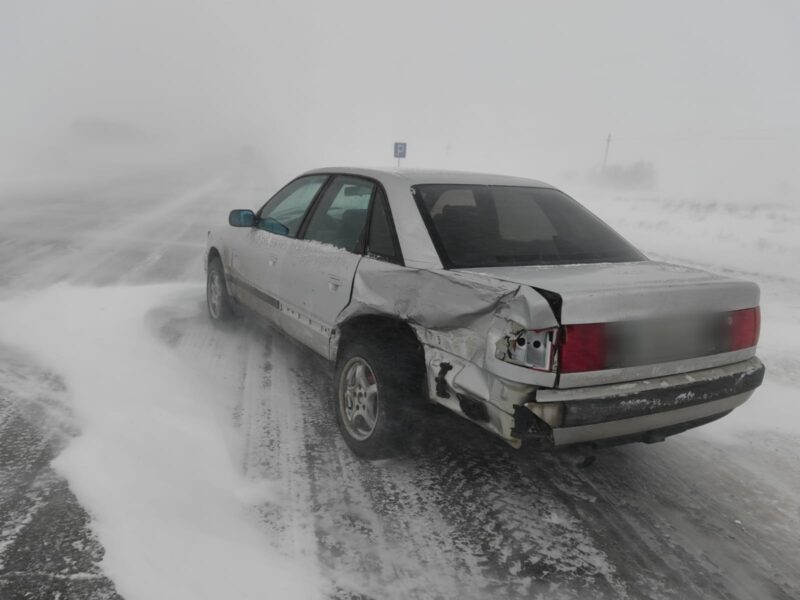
[412,184,646,268]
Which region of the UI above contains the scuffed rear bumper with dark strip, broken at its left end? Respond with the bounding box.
[514,357,764,446]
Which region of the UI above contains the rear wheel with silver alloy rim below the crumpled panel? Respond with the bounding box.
[335,338,419,460]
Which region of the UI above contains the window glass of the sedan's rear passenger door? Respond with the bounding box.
[303,176,375,252]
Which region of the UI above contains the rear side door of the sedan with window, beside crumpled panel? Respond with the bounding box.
[280,175,379,357]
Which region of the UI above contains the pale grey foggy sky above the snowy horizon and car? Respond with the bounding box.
[0,0,800,196]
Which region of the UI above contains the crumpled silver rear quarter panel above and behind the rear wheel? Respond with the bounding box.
[331,257,558,426]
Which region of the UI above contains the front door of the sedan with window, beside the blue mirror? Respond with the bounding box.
[230,175,328,322]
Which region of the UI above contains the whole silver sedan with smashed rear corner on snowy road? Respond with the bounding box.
[205,168,764,458]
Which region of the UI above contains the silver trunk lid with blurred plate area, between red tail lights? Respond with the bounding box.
[460,261,759,387]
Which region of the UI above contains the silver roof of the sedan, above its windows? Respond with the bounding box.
[303,167,553,188]
